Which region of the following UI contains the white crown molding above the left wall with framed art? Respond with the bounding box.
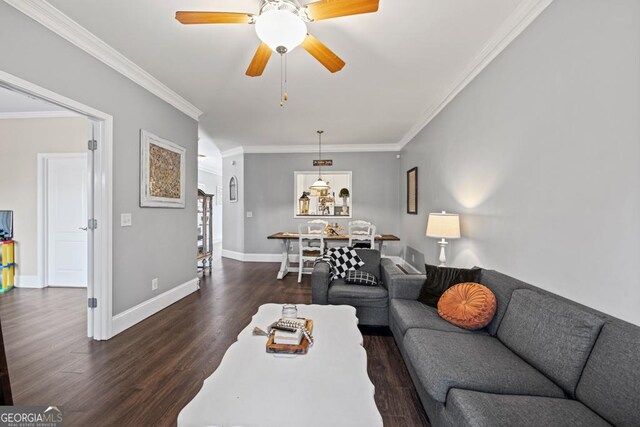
[4,0,202,121]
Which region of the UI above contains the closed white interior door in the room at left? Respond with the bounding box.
[46,153,89,287]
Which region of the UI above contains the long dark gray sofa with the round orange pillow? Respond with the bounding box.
[383,266,640,427]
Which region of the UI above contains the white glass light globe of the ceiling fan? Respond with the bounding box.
[256,10,307,52]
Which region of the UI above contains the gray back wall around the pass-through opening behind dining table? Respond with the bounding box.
[241,153,401,255]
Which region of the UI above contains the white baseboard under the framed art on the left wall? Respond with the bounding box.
[111,278,199,337]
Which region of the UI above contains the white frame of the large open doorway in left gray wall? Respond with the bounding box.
[0,70,113,340]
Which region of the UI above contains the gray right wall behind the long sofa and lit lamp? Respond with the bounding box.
[402,0,640,324]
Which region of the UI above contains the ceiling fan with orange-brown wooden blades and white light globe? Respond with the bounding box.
[176,0,379,77]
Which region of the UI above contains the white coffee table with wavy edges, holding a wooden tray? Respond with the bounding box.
[178,304,382,427]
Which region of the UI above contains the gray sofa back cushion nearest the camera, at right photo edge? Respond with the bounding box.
[576,321,640,426]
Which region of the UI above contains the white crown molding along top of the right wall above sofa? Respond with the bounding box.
[398,0,553,149]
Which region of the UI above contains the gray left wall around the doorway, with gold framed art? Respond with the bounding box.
[0,2,198,314]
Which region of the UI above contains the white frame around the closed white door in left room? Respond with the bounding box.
[37,152,91,288]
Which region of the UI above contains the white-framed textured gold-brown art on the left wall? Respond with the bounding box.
[140,130,187,208]
